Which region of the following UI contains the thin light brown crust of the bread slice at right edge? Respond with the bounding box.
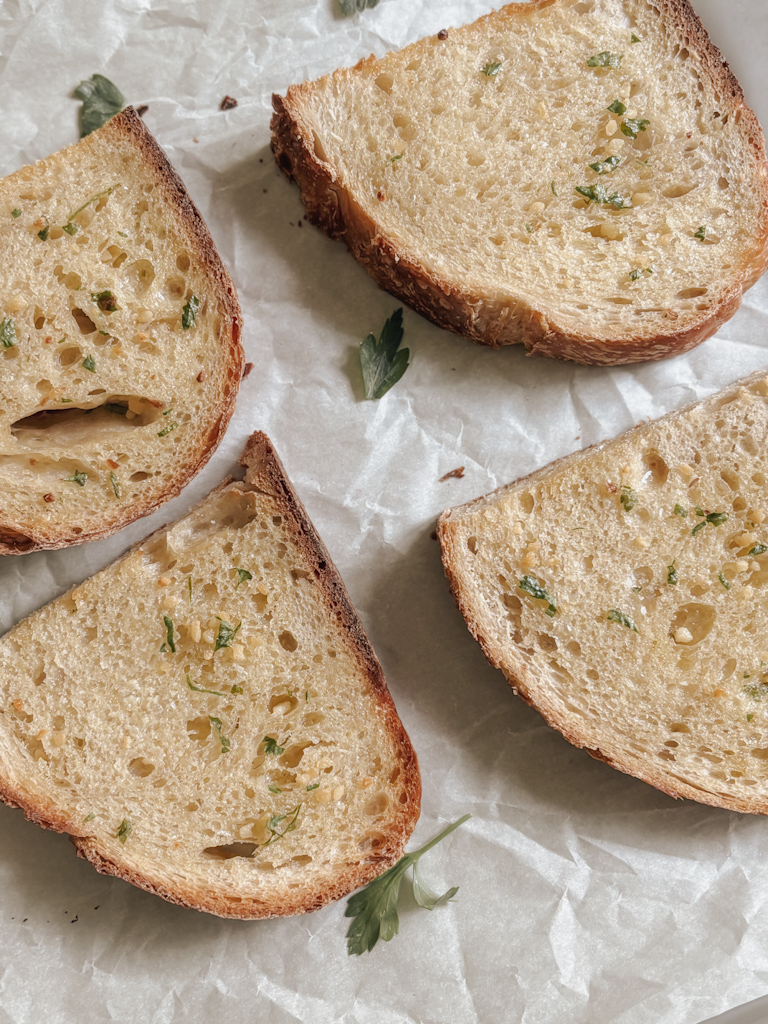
[437,370,768,815]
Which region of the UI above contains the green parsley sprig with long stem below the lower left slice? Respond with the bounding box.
[344,814,470,956]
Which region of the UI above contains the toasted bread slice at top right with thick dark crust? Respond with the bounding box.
[272,0,768,364]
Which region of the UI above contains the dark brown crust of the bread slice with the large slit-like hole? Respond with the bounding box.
[0,106,244,555]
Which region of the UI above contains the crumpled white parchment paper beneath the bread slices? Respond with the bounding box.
[0,0,768,1024]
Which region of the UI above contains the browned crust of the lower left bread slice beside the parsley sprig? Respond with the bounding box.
[0,432,421,921]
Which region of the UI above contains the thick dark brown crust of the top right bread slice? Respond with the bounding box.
[271,0,768,366]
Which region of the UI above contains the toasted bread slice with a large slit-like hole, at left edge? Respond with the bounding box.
[0,109,243,554]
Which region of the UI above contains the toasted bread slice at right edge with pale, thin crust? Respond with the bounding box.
[439,373,768,814]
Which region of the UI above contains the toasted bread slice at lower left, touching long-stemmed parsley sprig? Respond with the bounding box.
[0,434,421,919]
